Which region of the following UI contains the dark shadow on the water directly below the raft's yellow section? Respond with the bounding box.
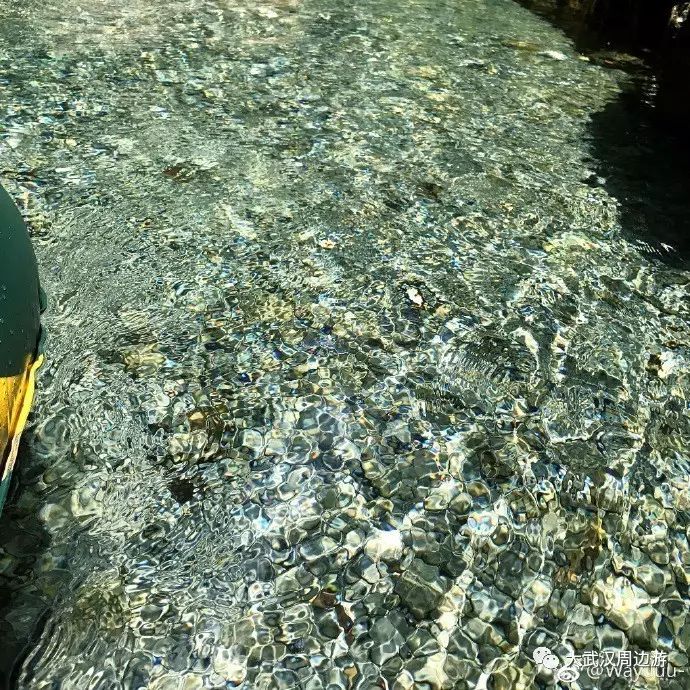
[0,431,50,690]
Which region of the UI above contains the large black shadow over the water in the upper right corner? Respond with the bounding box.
[520,0,690,268]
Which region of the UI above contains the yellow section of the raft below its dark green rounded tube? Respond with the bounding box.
[0,355,43,506]
